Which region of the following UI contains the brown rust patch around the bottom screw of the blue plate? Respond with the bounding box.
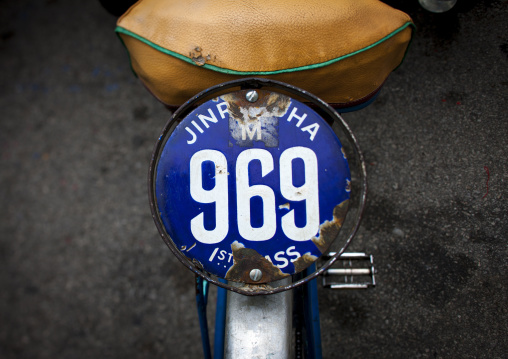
[226,241,289,284]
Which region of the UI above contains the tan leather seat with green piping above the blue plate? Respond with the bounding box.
[116,0,413,107]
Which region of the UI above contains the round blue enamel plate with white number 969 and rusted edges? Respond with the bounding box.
[153,90,351,284]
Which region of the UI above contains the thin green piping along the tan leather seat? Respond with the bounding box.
[115,22,414,76]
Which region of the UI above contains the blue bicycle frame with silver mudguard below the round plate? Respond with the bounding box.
[196,265,322,359]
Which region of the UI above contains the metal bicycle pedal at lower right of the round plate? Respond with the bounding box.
[322,252,376,289]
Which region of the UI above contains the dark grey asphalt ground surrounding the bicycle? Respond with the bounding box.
[0,0,508,359]
